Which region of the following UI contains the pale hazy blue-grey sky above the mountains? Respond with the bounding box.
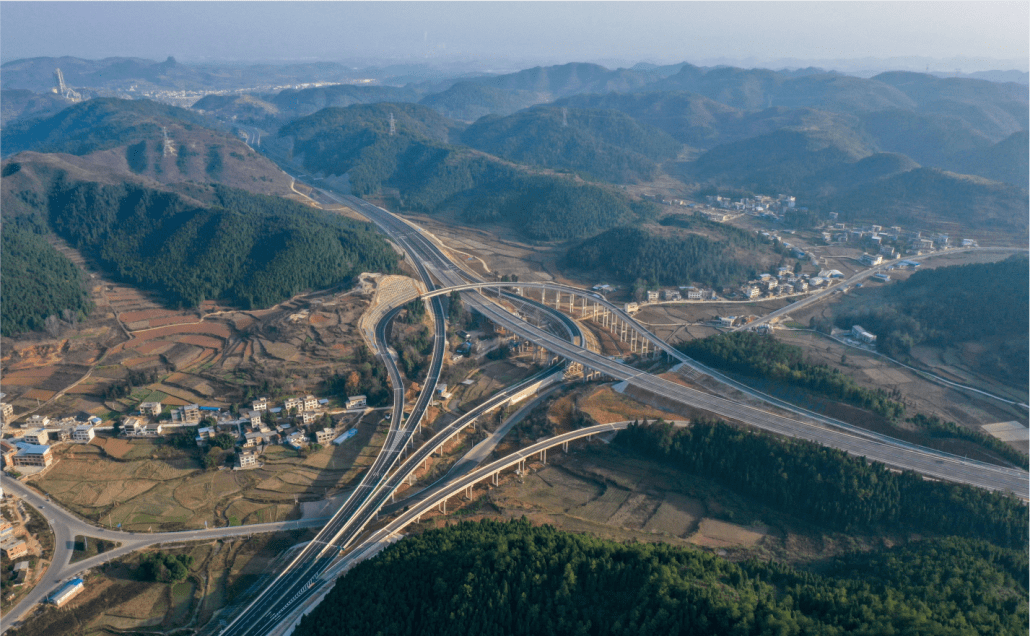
[0,0,1030,71]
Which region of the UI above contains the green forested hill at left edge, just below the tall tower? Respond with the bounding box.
[0,98,204,157]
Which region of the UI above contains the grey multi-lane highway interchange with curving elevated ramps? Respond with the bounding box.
[4,175,1028,636]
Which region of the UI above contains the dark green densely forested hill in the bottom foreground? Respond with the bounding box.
[296,520,1027,636]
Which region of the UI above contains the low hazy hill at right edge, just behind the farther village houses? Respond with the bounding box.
[822,168,1030,230]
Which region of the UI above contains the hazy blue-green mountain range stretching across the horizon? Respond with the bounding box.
[2,59,1030,239]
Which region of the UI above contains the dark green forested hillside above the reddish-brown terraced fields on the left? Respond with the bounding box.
[3,169,398,317]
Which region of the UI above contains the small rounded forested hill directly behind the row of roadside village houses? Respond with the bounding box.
[562,216,781,290]
